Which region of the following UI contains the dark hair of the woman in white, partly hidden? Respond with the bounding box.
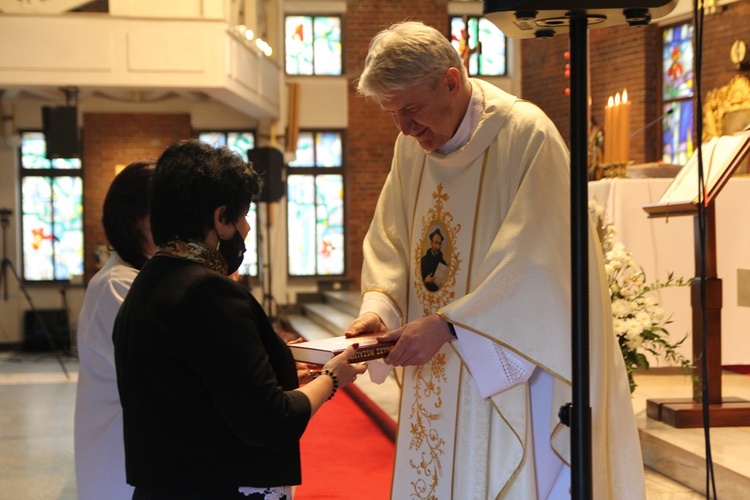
[102,159,156,269]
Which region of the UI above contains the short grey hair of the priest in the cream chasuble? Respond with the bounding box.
[357,21,468,99]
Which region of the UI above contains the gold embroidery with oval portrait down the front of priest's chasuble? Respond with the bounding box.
[408,184,461,499]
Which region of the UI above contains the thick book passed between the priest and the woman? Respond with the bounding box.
[288,333,396,365]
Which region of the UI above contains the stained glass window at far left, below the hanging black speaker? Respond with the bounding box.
[21,132,83,281]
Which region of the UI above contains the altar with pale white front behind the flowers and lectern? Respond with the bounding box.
[588,177,750,367]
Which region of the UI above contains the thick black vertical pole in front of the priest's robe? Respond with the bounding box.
[570,13,593,500]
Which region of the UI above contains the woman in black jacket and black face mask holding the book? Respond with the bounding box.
[113,140,365,500]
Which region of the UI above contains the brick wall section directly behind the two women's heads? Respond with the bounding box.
[82,113,191,283]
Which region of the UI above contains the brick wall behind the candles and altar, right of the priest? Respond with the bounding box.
[522,0,750,163]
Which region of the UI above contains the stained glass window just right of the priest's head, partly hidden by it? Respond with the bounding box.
[450,16,508,76]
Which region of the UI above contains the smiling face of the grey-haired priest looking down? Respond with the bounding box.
[380,68,466,152]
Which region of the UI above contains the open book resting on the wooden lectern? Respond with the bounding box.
[643,130,750,217]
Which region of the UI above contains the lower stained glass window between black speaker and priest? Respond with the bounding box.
[287,131,345,276]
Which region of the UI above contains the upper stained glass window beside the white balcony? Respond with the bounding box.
[284,16,342,75]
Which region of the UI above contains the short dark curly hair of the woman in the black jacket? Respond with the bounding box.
[151,139,262,245]
